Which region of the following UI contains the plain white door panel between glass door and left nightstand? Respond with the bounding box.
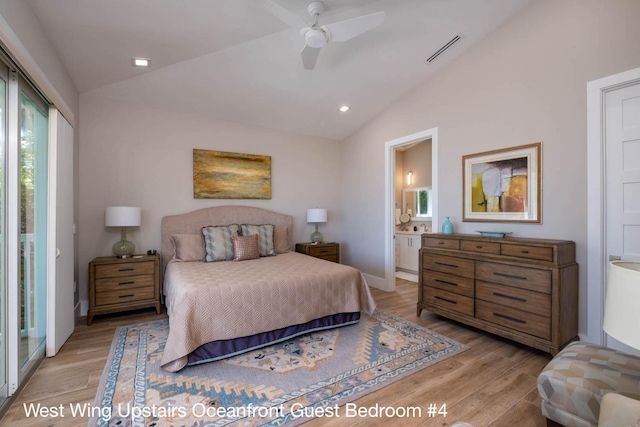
[46,108,75,357]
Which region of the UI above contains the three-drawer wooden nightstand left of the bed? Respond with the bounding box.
[87,255,162,325]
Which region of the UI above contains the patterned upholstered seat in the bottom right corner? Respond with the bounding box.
[538,342,640,426]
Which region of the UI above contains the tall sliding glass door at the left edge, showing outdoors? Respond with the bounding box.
[0,58,49,406]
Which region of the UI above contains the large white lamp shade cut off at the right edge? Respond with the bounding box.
[602,261,640,350]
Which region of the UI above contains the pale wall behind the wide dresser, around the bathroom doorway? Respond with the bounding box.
[342,0,640,342]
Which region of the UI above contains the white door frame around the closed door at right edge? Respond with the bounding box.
[585,68,640,345]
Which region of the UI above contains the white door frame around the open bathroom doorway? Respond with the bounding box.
[383,127,439,292]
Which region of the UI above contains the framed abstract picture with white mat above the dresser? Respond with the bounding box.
[462,142,542,224]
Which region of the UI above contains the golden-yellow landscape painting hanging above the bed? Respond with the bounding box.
[193,148,271,199]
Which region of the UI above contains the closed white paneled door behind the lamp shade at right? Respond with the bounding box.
[604,84,640,352]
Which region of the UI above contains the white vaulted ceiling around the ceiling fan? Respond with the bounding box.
[30,0,533,140]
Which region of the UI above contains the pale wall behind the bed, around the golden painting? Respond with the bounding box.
[79,92,343,310]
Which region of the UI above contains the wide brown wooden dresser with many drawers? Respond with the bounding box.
[418,234,578,355]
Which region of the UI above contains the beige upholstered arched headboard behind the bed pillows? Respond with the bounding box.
[161,206,293,269]
